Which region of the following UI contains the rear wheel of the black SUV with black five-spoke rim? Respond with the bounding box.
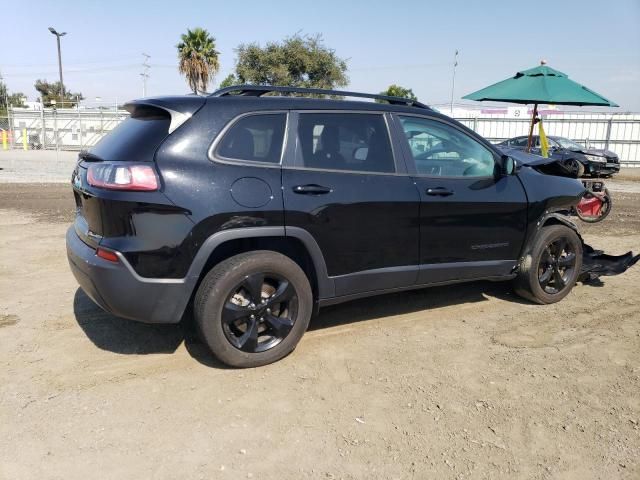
[194,250,313,368]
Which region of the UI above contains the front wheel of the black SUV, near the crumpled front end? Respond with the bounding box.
[514,225,582,304]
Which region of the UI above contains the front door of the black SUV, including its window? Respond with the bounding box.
[397,115,527,284]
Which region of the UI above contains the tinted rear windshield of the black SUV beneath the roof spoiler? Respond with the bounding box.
[89,108,171,162]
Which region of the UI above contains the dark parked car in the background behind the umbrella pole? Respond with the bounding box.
[498,136,620,177]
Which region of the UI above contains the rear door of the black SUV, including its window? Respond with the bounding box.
[282,111,420,295]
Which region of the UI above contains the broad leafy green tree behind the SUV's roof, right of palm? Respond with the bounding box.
[232,34,349,88]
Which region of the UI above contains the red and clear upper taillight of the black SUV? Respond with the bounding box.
[87,162,158,192]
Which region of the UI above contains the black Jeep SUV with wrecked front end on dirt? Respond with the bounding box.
[67,86,584,367]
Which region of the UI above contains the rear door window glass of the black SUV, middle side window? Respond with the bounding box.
[296,113,395,173]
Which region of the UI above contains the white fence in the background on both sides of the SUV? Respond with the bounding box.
[5,109,640,167]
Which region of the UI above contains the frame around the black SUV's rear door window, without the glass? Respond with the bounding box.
[282,109,408,176]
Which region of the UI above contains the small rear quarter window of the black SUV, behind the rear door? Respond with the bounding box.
[216,113,286,164]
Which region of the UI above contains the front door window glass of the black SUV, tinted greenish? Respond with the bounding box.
[400,116,495,177]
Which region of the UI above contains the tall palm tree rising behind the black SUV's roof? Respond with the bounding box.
[176,27,220,94]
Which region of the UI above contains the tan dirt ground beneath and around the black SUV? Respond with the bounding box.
[0,184,640,480]
